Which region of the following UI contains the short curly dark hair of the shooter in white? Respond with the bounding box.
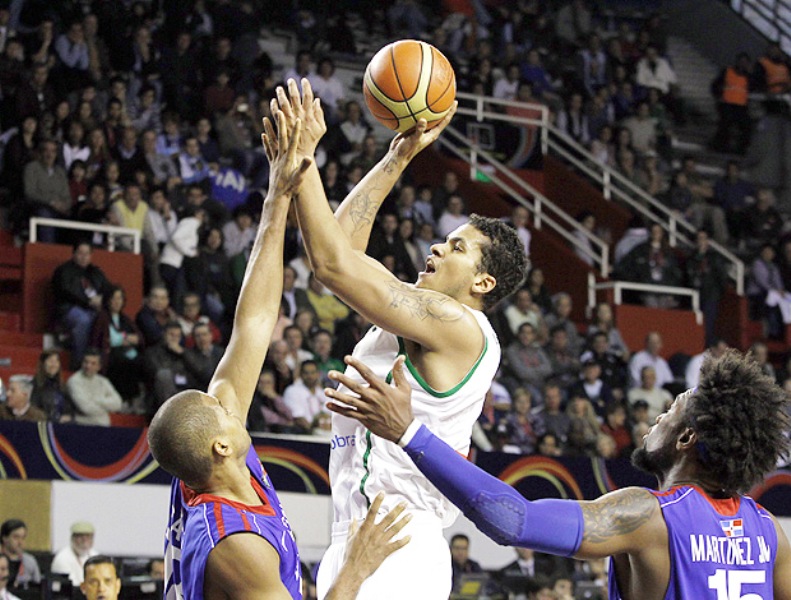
[470,214,527,310]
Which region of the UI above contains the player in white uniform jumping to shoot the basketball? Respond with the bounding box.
[272,79,525,600]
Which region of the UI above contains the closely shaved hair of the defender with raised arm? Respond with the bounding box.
[148,390,220,488]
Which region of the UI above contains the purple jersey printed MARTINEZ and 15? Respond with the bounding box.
[610,485,777,600]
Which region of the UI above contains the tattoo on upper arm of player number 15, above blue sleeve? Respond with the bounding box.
[582,489,659,544]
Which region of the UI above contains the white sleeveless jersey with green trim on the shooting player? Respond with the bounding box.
[330,307,500,527]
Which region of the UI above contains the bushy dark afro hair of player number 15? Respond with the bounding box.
[686,350,790,494]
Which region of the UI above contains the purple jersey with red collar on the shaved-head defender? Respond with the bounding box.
[165,445,302,600]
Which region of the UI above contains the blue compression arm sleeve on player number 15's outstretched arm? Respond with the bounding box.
[404,425,584,556]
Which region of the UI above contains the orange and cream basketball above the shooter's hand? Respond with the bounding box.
[363,40,456,132]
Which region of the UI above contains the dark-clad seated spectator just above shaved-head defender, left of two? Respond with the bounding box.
[143,321,196,415]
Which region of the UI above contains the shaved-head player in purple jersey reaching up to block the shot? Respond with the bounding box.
[148,115,408,600]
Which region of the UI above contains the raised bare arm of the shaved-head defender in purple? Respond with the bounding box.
[208,115,311,422]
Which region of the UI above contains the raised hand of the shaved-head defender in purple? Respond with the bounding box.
[261,111,312,197]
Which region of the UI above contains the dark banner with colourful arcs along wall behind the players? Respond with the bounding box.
[0,421,791,517]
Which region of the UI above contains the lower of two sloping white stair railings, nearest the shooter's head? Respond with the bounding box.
[439,127,610,277]
